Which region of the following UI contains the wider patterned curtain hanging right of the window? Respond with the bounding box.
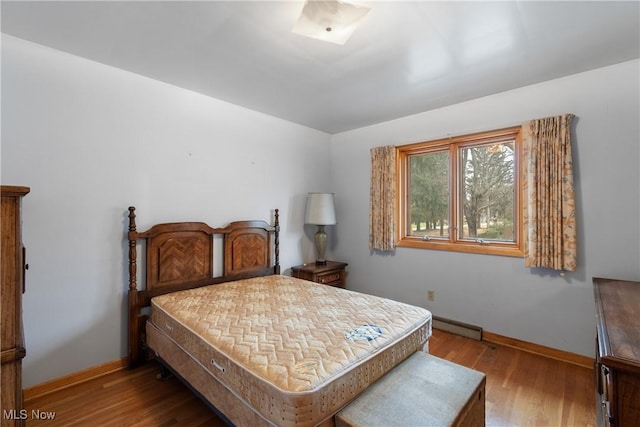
[523,114,577,271]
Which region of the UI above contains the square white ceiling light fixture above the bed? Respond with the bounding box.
[292,0,370,44]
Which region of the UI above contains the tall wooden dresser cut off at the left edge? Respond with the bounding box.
[0,185,29,427]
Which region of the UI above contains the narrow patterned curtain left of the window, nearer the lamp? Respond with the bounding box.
[369,146,396,251]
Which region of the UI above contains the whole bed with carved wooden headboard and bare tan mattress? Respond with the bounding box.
[128,207,431,426]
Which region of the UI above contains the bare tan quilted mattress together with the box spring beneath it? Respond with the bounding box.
[147,275,431,426]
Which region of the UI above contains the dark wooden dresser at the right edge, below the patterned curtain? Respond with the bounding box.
[593,278,640,427]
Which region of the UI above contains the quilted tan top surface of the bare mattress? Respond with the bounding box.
[152,275,431,393]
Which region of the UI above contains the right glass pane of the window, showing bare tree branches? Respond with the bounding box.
[460,141,516,242]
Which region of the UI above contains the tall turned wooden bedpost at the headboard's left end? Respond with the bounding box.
[128,206,140,368]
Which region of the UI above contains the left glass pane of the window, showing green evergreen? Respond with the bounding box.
[406,151,450,238]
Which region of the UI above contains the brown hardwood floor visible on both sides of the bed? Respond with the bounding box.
[25,330,596,427]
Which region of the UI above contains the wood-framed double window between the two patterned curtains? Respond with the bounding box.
[397,126,523,256]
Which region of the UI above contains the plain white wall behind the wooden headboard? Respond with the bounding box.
[1,36,330,387]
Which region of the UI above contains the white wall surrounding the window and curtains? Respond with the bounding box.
[332,60,640,356]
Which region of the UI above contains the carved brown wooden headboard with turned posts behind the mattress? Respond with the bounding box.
[128,206,280,368]
